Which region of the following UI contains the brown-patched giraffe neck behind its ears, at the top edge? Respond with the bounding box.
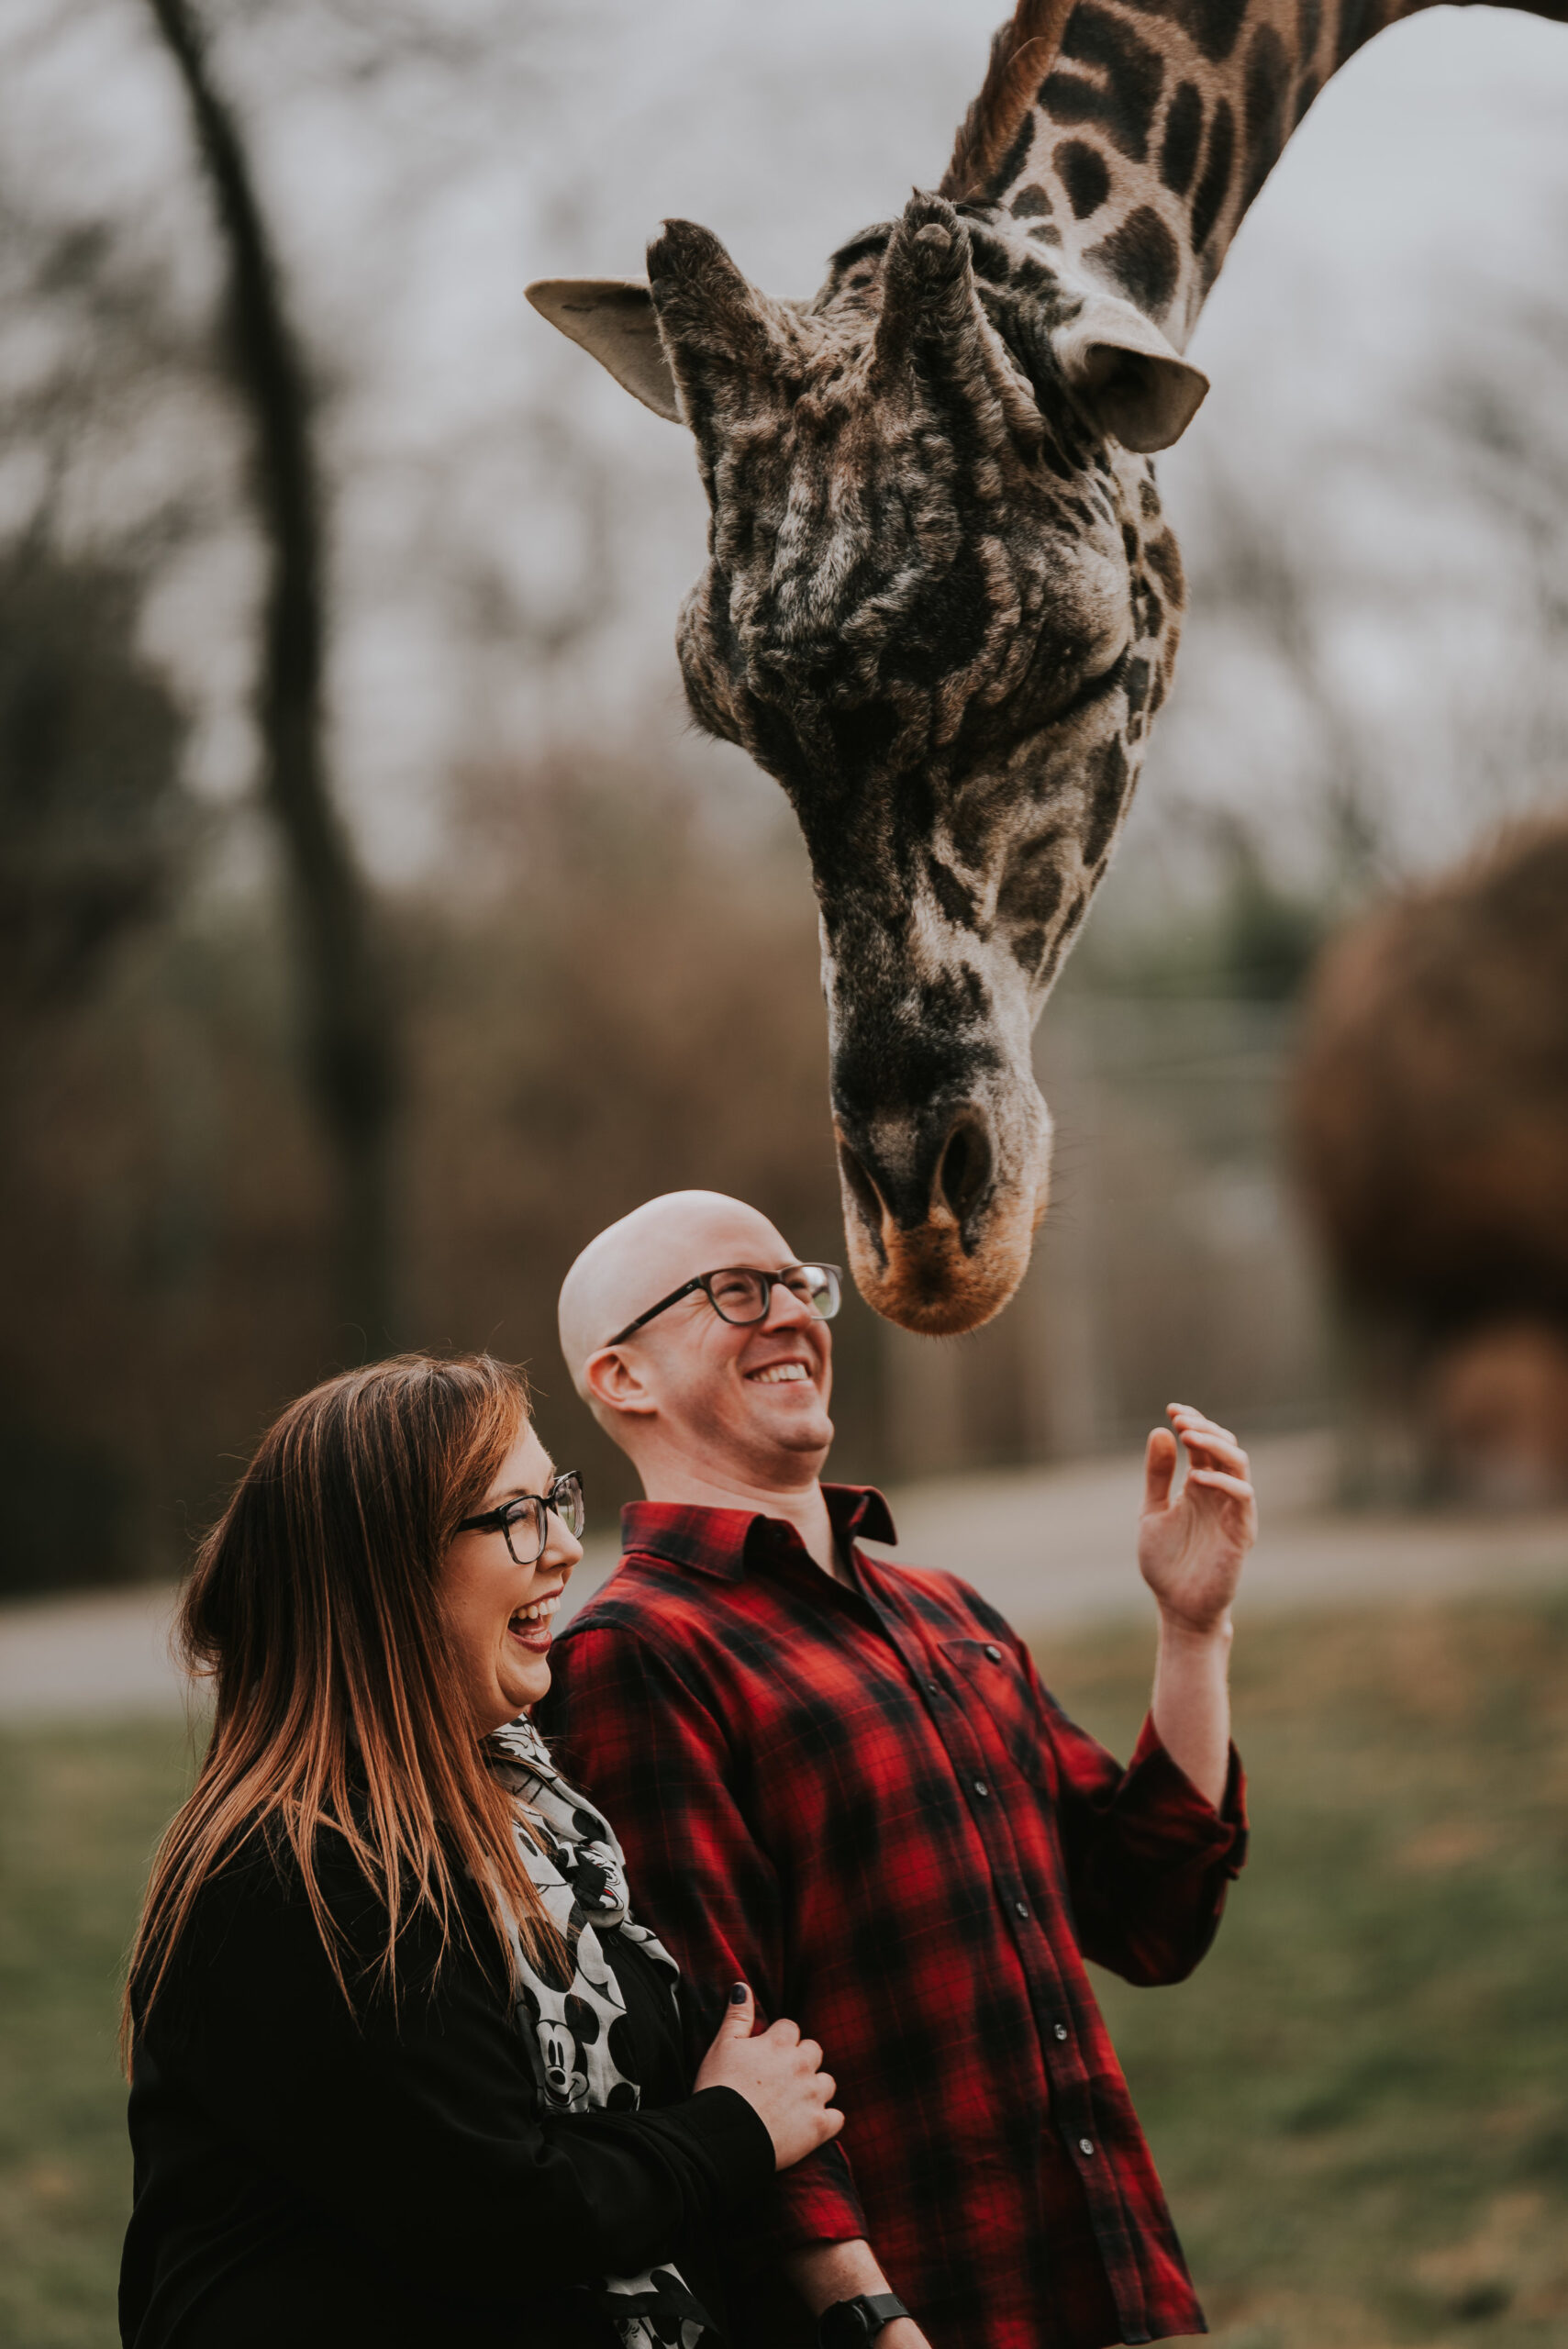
[984,0,1445,350]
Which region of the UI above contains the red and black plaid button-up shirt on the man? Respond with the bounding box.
[538,1486,1247,2349]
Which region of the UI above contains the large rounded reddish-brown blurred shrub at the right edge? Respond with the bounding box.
[1294,815,1568,1506]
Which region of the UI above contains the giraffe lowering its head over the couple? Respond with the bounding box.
[528,0,1568,1334]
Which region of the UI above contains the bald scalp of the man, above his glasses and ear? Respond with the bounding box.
[561,1191,791,1407]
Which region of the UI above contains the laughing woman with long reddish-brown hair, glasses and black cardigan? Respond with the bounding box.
[119,1355,840,2349]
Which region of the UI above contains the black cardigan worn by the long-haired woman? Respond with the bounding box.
[119,1837,773,2349]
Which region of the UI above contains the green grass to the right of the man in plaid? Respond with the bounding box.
[1042,1602,1568,2349]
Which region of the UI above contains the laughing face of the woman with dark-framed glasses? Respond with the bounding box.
[441,1421,582,1736]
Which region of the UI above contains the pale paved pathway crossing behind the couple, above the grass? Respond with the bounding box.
[0,1435,1568,1720]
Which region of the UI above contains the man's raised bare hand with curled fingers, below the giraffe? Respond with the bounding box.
[1139,1402,1258,1635]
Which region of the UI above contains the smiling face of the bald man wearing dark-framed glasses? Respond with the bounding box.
[617,1208,833,1486]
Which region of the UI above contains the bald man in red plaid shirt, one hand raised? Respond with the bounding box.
[538,1191,1256,2349]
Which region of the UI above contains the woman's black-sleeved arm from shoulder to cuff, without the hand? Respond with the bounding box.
[148,1858,773,2302]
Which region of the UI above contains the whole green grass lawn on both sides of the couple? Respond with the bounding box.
[0,1602,1568,2349]
